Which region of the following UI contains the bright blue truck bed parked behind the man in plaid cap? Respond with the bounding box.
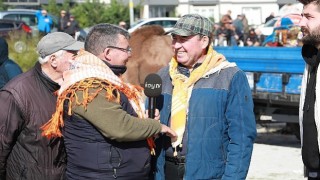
[214,47,305,138]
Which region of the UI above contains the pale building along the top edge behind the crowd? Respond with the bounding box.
[3,0,297,25]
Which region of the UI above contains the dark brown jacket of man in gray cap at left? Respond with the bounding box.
[0,63,66,180]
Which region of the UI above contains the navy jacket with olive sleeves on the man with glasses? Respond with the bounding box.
[63,63,161,180]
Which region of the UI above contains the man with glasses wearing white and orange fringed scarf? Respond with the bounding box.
[42,24,176,180]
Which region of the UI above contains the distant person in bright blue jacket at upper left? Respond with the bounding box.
[36,9,53,36]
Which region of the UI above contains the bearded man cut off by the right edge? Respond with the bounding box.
[299,0,320,180]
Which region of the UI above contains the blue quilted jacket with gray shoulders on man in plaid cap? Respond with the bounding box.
[156,64,256,180]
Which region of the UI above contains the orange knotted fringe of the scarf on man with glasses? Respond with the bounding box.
[41,78,155,155]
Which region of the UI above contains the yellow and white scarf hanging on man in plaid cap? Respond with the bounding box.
[169,47,225,156]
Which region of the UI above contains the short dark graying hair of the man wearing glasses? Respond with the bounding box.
[84,23,130,55]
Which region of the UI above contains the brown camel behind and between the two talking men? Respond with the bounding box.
[123,25,173,85]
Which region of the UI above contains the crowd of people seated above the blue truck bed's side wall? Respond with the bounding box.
[213,10,302,47]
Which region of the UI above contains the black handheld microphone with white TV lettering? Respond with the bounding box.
[144,73,162,119]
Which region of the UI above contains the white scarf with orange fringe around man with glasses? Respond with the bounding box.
[41,51,155,154]
